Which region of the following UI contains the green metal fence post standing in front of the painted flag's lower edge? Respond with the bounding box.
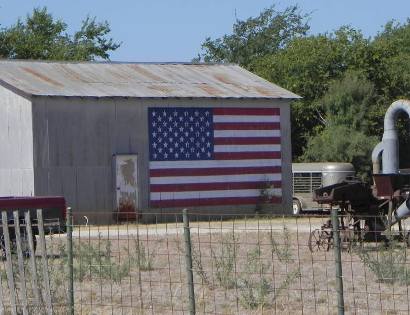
[182,209,195,315]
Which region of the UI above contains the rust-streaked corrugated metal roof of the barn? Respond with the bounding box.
[0,60,299,99]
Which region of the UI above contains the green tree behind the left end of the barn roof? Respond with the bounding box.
[0,8,120,61]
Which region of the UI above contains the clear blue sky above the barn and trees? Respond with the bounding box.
[0,0,410,62]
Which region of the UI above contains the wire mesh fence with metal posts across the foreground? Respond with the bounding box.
[0,212,410,314]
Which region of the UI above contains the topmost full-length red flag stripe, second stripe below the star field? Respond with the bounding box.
[149,166,281,177]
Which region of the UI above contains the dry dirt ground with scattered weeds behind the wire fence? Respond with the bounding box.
[2,218,410,314]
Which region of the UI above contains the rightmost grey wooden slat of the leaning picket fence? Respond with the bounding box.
[37,209,53,315]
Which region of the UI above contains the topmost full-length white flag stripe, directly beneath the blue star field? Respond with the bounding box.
[149,159,281,170]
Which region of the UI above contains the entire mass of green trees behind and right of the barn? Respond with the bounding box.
[202,6,410,175]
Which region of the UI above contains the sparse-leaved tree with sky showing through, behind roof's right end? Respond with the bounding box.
[200,5,309,67]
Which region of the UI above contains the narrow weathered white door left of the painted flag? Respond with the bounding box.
[115,154,138,218]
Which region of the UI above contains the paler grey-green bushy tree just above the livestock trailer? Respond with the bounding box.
[301,72,378,179]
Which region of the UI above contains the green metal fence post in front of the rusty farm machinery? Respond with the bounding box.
[331,208,345,315]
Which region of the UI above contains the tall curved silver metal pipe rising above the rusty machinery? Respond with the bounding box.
[372,100,410,174]
